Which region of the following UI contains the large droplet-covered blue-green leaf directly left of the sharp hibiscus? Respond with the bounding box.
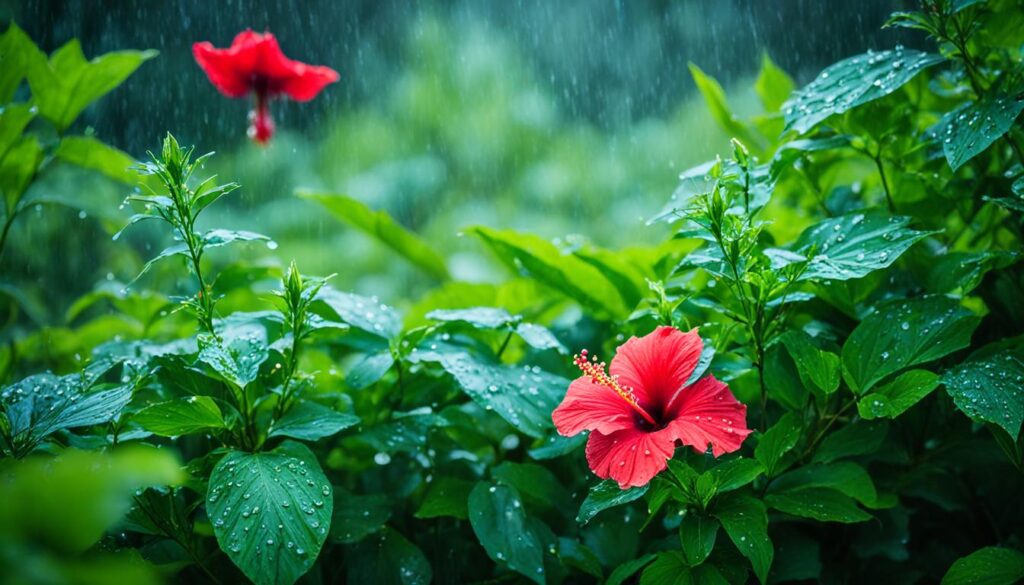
[415,350,569,438]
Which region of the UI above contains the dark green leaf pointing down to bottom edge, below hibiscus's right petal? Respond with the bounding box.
[712,492,775,583]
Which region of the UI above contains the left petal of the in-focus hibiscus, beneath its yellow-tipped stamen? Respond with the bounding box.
[551,376,636,436]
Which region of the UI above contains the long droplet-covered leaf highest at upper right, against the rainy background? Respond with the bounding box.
[782,47,944,134]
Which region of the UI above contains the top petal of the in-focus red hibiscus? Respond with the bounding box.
[609,327,703,414]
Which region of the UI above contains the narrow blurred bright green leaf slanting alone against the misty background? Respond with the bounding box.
[297,190,451,281]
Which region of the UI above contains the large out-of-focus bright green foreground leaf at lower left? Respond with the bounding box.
[0,445,184,553]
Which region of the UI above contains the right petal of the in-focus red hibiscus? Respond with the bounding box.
[660,376,752,457]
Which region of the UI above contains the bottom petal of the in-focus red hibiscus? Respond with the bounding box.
[587,427,676,490]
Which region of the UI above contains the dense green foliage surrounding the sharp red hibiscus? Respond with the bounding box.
[0,0,1024,585]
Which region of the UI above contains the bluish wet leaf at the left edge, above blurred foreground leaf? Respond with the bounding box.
[0,374,133,449]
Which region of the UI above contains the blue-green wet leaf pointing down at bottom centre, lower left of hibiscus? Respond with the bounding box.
[469,482,545,585]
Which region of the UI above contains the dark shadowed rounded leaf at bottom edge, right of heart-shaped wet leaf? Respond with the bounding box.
[345,528,433,585]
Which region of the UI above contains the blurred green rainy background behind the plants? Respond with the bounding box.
[0,0,913,311]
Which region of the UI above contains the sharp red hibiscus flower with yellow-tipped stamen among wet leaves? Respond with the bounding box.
[551,327,751,490]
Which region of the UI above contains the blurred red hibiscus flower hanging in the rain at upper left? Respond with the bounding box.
[193,30,338,144]
